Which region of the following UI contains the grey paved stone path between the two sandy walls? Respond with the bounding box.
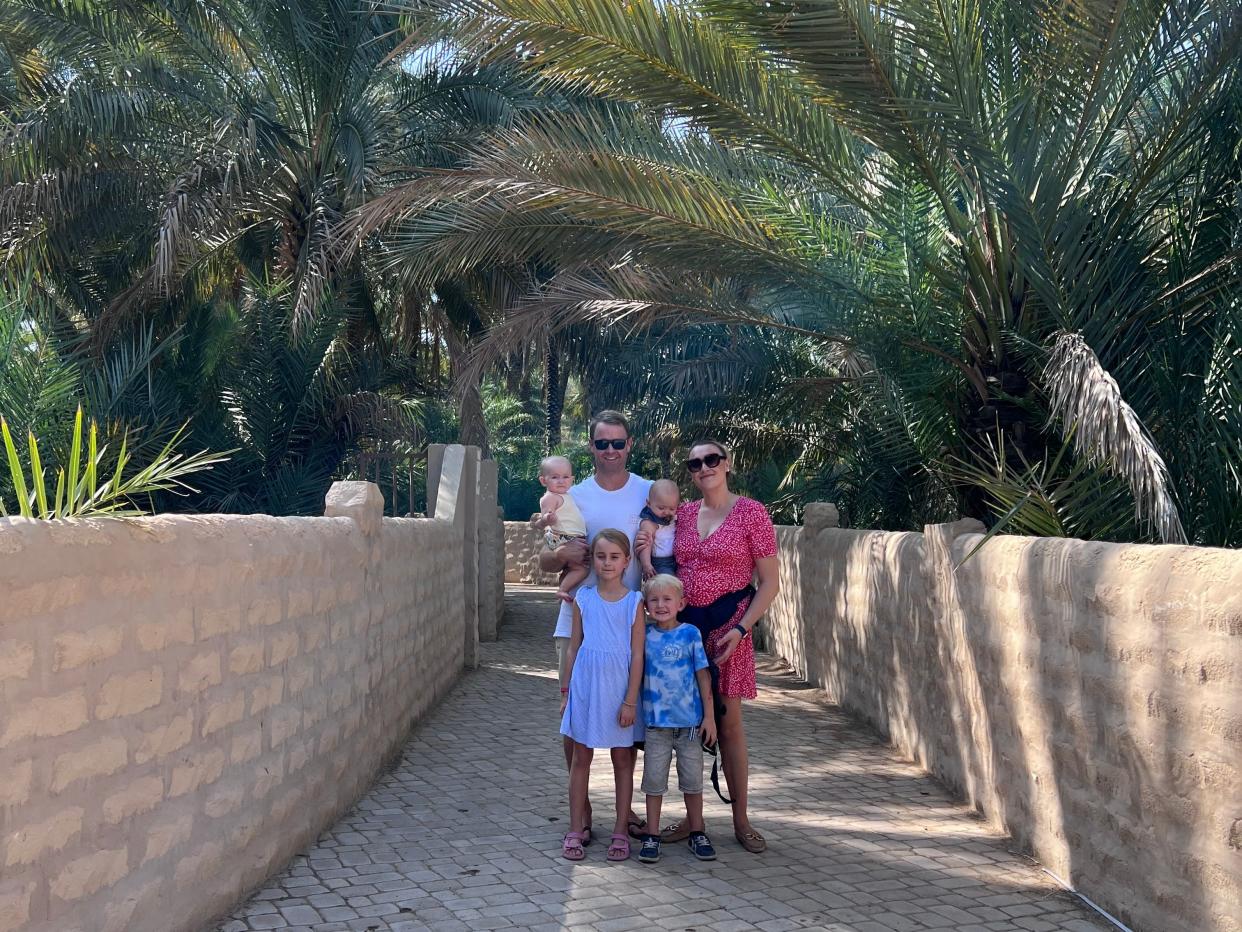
[219,588,1108,932]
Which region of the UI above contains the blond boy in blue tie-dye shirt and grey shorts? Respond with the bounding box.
[638,574,715,864]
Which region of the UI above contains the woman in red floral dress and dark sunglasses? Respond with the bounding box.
[661,441,780,854]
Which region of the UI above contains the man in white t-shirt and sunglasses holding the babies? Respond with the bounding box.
[539,411,651,765]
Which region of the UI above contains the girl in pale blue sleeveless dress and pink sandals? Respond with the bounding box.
[560,528,646,861]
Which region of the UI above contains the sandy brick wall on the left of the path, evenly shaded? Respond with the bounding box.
[0,499,463,932]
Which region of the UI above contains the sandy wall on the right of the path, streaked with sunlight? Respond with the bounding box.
[768,518,1242,932]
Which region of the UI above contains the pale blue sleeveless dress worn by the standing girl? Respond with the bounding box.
[560,585,645,748]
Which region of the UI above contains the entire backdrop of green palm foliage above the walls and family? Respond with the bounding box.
[0,0,1242,544]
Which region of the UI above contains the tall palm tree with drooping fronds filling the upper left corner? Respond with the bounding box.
[0,0,558,462]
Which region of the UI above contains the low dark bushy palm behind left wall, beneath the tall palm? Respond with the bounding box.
[164,280,424,514]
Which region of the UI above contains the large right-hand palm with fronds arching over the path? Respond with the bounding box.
[365,0,1242,543]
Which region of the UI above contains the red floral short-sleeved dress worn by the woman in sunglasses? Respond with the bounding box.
[673,496,776,698]
